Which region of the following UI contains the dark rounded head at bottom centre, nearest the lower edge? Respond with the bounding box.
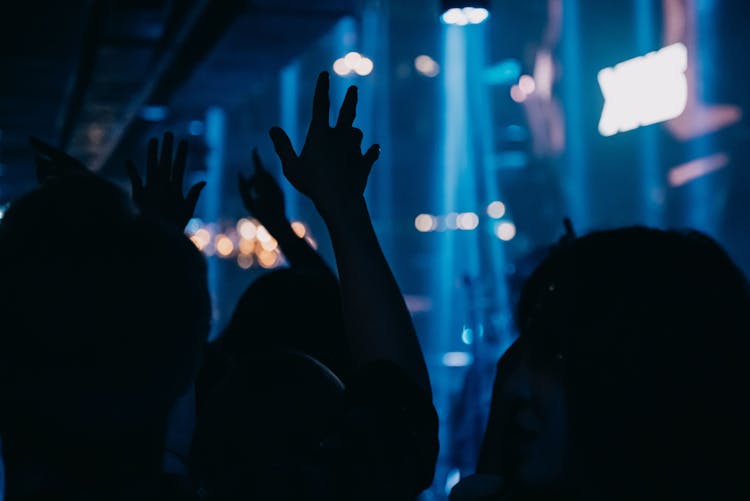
[192,351,344,501]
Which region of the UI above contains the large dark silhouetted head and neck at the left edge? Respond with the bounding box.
[0,176,210,492]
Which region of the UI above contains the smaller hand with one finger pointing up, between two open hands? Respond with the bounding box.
[237,149,287,227]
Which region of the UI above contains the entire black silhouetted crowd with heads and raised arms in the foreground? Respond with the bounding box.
[0,72,750,501]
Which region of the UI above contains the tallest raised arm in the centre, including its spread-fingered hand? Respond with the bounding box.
[270,72,430,392]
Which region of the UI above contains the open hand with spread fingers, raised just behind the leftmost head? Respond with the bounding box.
[128,132,206,229]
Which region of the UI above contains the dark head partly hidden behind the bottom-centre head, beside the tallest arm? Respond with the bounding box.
[219,268,351,379]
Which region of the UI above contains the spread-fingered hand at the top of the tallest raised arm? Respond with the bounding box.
[269,72,380,209]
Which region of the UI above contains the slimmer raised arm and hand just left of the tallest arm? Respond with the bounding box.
[238,150,335,274]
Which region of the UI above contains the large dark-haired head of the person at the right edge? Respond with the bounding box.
[516,227,750,499]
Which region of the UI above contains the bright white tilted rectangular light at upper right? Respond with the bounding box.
[598,43,688,136]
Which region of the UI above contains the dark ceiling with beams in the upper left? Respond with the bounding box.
[0,0,355,203]
